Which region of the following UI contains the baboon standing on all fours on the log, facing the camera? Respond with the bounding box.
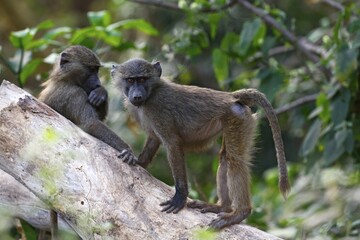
[111,59,290,229]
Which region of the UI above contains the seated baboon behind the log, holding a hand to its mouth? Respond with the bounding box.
[39,45,136,239]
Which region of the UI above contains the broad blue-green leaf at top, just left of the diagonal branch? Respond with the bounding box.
[238,18,263,56]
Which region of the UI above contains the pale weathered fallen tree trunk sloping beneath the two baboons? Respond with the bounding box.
[0,81,279,240]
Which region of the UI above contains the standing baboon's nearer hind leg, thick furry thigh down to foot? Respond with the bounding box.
[210,114,256,229]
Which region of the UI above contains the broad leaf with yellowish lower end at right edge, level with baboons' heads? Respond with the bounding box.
[335,44,358,86]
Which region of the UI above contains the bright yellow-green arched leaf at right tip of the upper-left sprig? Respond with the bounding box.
[106,19,158,36]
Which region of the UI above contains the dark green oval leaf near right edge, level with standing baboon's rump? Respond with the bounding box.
[331,88,351,126]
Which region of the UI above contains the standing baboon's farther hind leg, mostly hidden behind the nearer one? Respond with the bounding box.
[187,138,231,213]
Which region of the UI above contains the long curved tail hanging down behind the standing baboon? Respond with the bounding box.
[233,88,290,198]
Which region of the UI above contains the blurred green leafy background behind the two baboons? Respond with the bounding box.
[0,0,360,239]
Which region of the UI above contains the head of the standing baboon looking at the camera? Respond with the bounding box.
[111,59,162,107]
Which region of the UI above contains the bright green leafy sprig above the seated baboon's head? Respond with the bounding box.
[1,11,158,87]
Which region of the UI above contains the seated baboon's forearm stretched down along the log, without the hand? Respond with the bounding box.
[80,119,130,152]
